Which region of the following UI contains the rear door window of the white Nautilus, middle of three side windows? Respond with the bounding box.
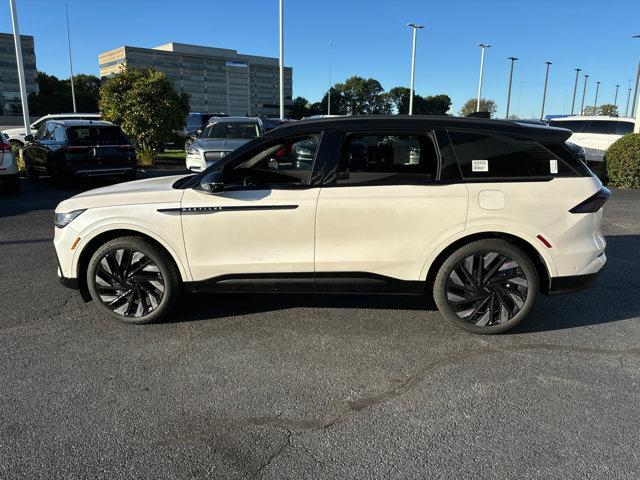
[337,132,438,185]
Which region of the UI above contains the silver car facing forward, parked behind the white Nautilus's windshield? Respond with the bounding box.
[187,117,264,172]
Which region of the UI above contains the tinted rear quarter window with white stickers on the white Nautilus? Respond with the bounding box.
[449,131,578,180]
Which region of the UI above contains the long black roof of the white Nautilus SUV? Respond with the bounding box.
[266,115,571,142]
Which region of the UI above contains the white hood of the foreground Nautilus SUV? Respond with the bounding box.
[56,175,188,213]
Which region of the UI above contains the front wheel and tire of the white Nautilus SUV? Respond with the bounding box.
[86,237,182,325]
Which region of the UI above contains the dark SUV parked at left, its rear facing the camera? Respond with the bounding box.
[24,120,138,180]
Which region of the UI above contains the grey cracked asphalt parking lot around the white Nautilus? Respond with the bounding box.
[0,174,640,479]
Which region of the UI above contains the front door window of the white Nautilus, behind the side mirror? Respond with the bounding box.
[223,134,320,190]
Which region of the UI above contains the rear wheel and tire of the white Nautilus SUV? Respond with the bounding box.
[433,239,539,335]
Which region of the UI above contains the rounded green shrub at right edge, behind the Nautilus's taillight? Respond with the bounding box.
[605,133,640,188]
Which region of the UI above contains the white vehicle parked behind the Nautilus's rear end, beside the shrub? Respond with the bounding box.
[549,116,635,170]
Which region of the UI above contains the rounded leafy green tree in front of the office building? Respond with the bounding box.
[99,67,189,161]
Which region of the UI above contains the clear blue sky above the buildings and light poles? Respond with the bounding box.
[0,0,640,117]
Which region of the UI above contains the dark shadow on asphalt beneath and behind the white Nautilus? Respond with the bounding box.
[167,235,640,334]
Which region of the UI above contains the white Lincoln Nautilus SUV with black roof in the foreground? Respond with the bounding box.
[54,116,609,333]
